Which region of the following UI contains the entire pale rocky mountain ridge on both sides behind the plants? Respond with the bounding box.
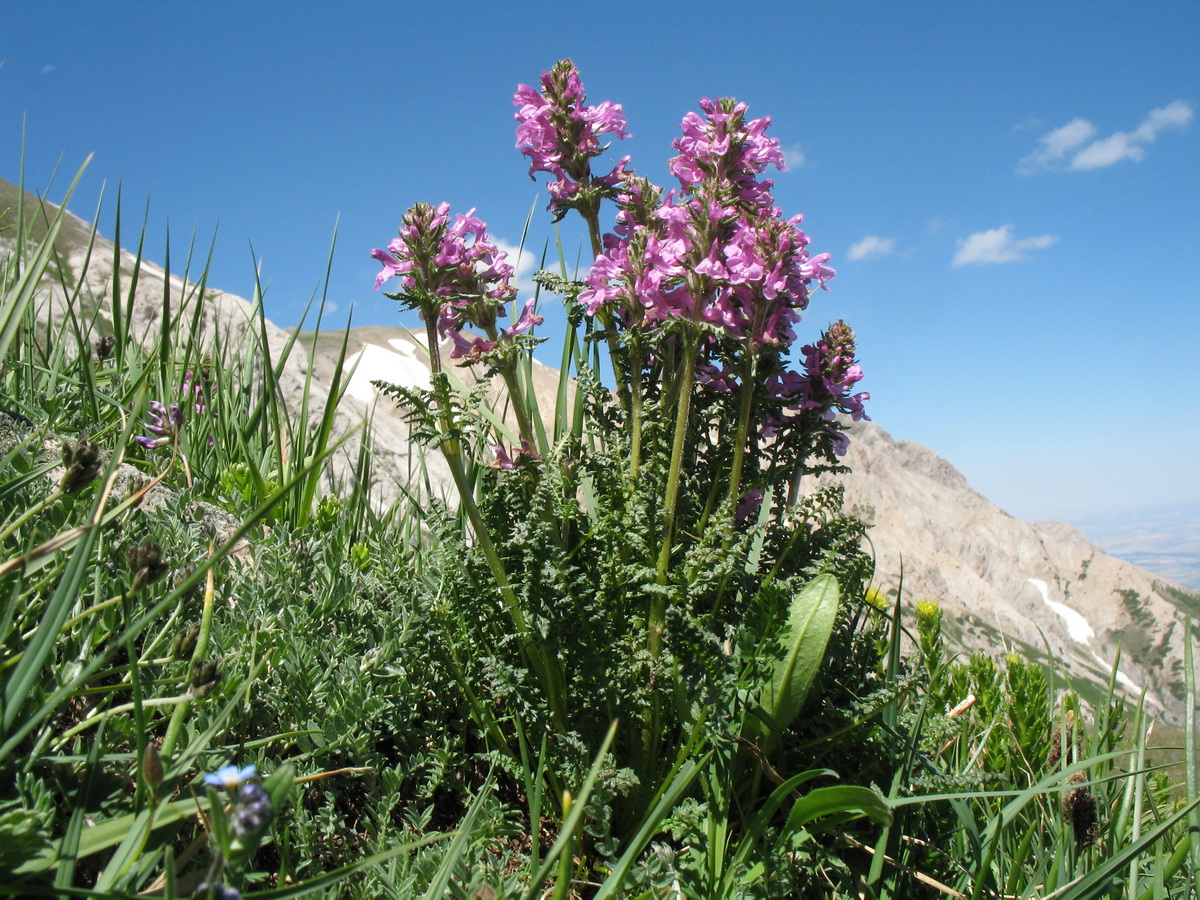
[9,174,1200,724]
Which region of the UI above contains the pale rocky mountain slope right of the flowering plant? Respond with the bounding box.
[816,422,1200,724]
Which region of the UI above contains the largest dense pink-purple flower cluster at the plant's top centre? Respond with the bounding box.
[578,98,834,353]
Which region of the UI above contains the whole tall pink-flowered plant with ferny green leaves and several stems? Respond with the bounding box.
[372,61,869,840]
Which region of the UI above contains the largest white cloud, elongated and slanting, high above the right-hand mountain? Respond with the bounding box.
[1016,100,1195,175]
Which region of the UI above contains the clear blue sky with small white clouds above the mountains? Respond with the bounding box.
[0,0,1200,520]
